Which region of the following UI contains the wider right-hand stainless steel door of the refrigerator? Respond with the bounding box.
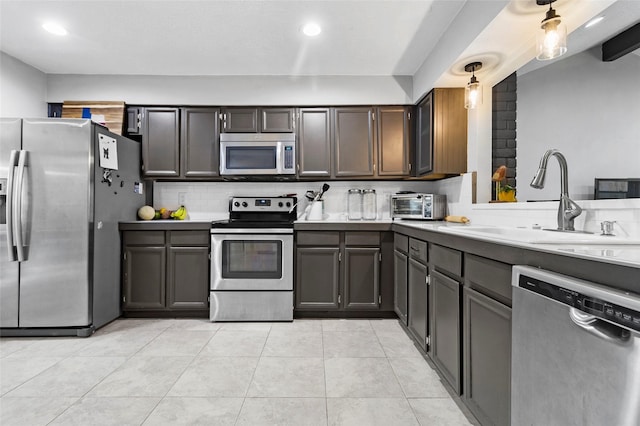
[19,119,92,327]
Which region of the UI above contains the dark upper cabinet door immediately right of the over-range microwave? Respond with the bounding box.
[298,108,332,177]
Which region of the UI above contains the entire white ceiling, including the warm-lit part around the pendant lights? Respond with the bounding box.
[0,0,640,87]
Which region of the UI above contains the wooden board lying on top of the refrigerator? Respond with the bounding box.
[62,101,125,135]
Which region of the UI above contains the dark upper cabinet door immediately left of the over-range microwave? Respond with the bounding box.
[181,108,220,178]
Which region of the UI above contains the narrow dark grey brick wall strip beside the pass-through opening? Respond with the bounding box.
[491,72,518,200]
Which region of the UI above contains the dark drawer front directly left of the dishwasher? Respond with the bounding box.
[464,254,511,306]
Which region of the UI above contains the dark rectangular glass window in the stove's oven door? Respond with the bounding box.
[222,240,282,279]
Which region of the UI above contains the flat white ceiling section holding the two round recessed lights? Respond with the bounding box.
[0,0,465,76]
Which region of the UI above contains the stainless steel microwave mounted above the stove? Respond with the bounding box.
[220,133,296,176]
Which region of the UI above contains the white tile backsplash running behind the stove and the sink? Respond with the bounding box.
[154,173,640,238]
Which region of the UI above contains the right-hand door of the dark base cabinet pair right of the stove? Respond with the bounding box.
[344,247,380,310]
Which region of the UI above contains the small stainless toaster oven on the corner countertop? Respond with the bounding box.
[391,193,447,220]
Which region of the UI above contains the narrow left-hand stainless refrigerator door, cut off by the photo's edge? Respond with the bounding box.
[0,118,22,327]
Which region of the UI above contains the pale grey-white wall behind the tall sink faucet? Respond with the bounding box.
[517,48,640,201]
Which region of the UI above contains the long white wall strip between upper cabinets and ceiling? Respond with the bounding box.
[47,74,413,106]
